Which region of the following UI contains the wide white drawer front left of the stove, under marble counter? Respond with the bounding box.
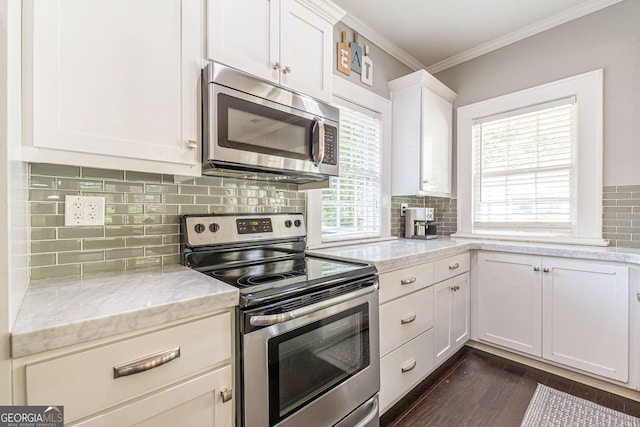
[25,313,231,421]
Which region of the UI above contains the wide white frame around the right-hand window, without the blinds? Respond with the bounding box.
[454,69,607,246]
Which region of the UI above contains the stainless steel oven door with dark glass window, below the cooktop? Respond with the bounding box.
[241,284,380,427]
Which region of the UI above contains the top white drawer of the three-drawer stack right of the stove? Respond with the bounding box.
[380,262,433,304]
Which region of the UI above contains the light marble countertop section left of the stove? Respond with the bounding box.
[11,265,239,357]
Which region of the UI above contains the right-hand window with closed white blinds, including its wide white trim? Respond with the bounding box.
[456,70,604,244]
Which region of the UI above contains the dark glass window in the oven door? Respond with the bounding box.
[268,304,369,425]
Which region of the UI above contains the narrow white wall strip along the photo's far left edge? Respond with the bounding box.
[0,0,28,405]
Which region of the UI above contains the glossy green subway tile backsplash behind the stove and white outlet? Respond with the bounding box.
[29,163,305,280]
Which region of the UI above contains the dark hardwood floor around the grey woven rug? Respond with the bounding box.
[380,347,640,427]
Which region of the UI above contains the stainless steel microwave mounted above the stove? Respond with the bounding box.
[202,63,339,184]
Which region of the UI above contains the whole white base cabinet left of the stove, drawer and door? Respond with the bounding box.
[14,311,234,427]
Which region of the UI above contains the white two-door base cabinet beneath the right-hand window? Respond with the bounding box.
[477,252,629,383]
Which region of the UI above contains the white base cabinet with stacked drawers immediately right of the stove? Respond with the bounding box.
[380,253,469,413]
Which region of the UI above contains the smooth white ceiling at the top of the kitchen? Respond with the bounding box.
[334,0,621,72]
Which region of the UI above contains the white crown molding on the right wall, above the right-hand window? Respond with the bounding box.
[426,0,622,74]
